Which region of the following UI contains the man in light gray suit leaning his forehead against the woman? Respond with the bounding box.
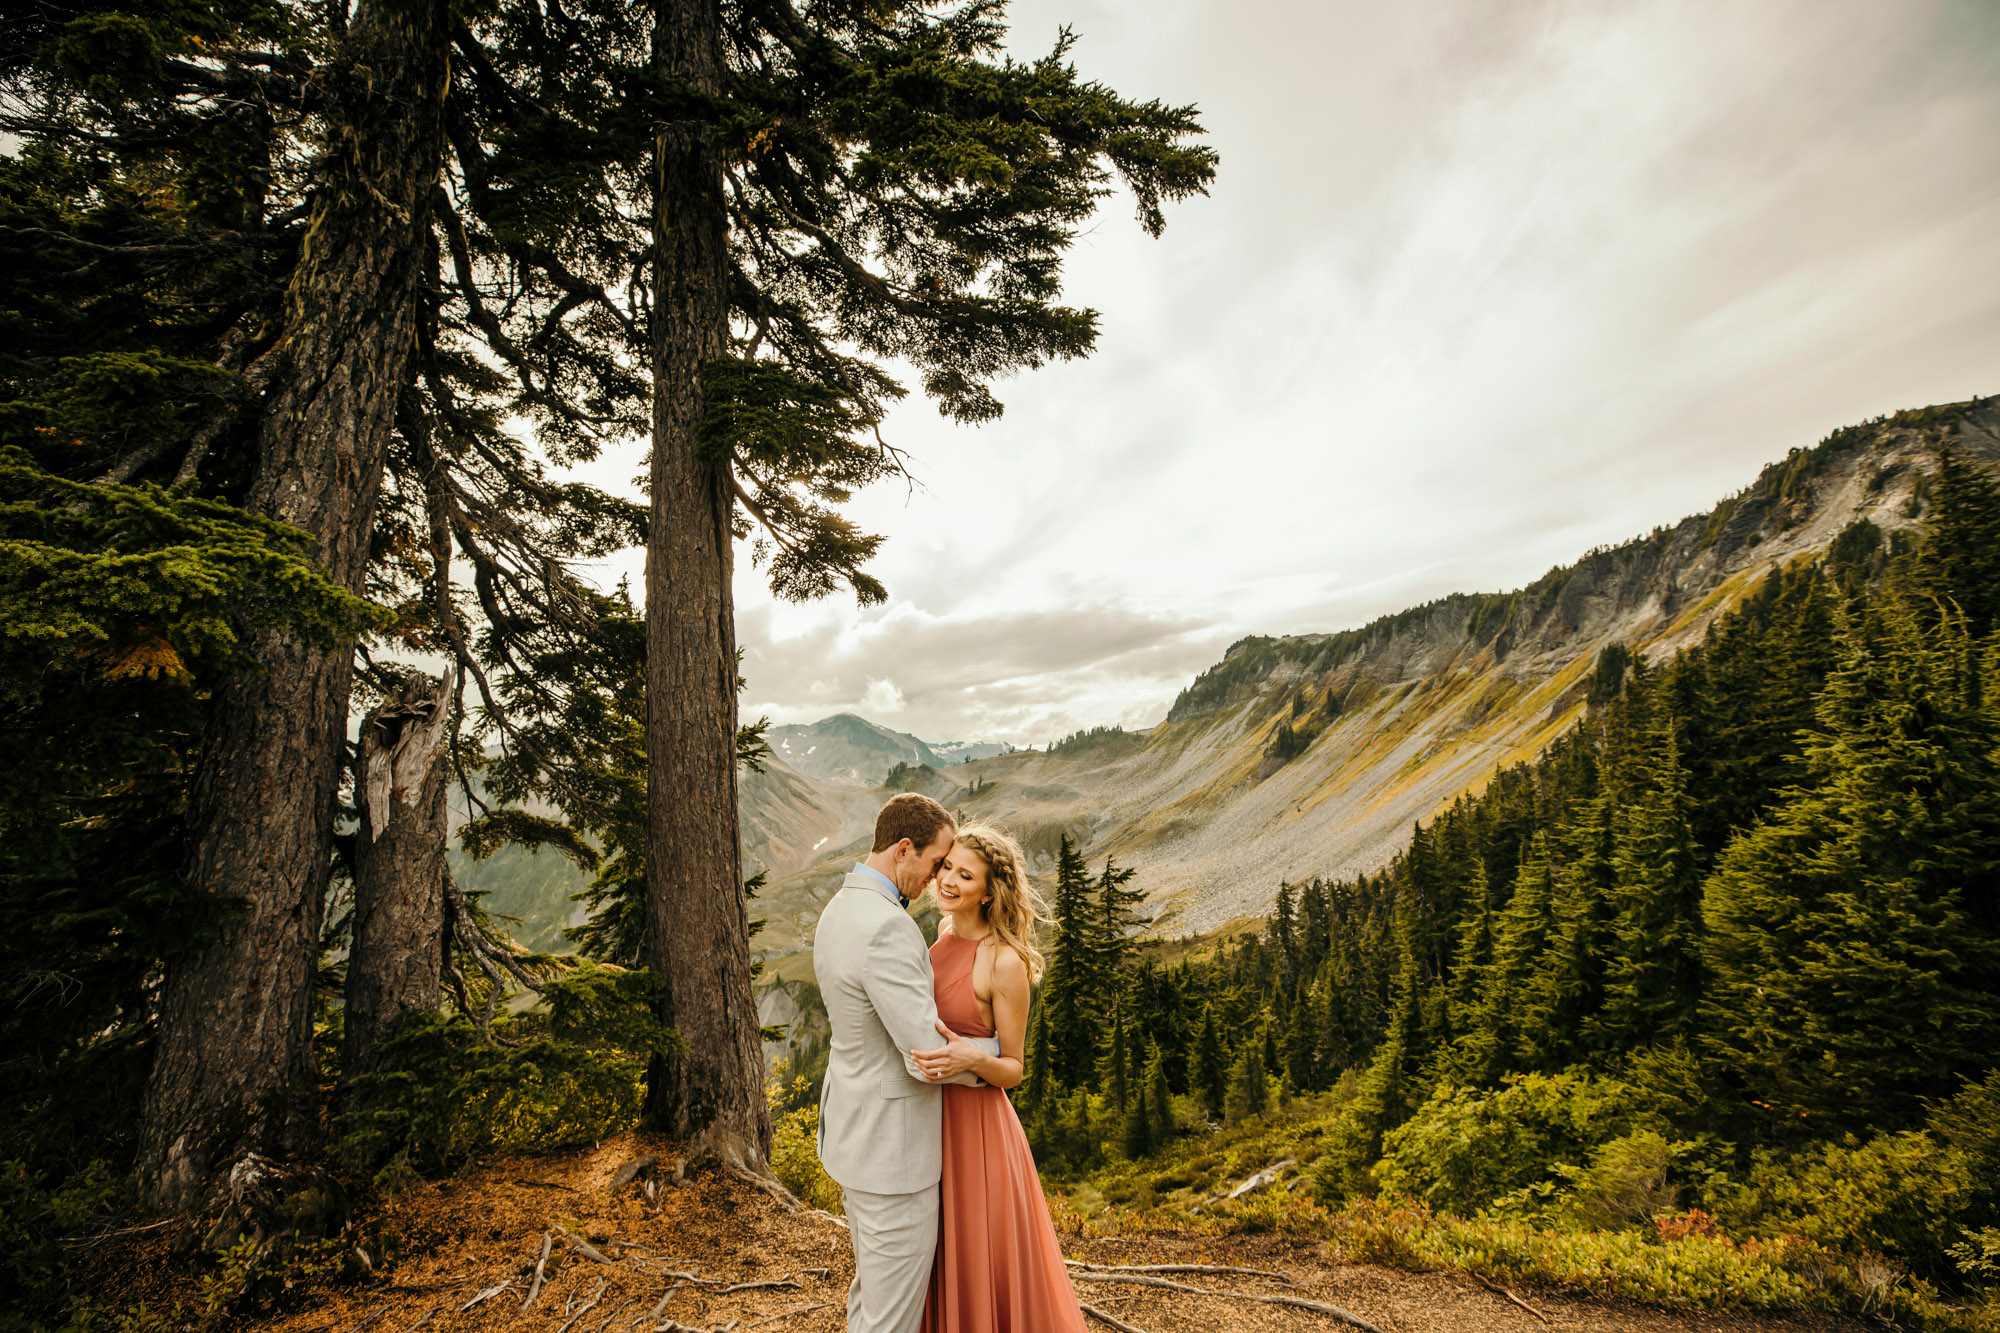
[812,793,972,1333]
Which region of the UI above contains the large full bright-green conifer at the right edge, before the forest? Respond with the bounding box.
[1704,602,2000,1127]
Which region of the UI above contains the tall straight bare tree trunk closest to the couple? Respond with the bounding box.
[646,0,770,1171]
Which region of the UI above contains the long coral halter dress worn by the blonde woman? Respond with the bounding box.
[922,935,1084,1333]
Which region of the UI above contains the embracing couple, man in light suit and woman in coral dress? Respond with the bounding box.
[812,793,1084,1333]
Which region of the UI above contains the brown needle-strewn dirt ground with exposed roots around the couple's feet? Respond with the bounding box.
[96,1135,1862,1333]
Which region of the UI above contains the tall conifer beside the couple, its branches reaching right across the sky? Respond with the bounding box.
[634,0,1214,1157]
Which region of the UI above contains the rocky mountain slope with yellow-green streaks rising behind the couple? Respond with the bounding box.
[760,400,2000,964]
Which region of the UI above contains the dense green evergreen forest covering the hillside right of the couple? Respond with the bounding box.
[892,438,2000,1327]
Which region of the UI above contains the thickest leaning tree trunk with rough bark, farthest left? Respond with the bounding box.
[138,0,448,1211]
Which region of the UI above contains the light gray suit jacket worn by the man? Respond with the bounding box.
[812,873,978,1195]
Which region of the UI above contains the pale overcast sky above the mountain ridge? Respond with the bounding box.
[608,0,2000,745]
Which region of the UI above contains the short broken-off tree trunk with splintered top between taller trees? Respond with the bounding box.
[340,675,452,1081]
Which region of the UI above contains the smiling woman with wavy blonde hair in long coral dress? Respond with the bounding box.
[918,827,1084,1333]
